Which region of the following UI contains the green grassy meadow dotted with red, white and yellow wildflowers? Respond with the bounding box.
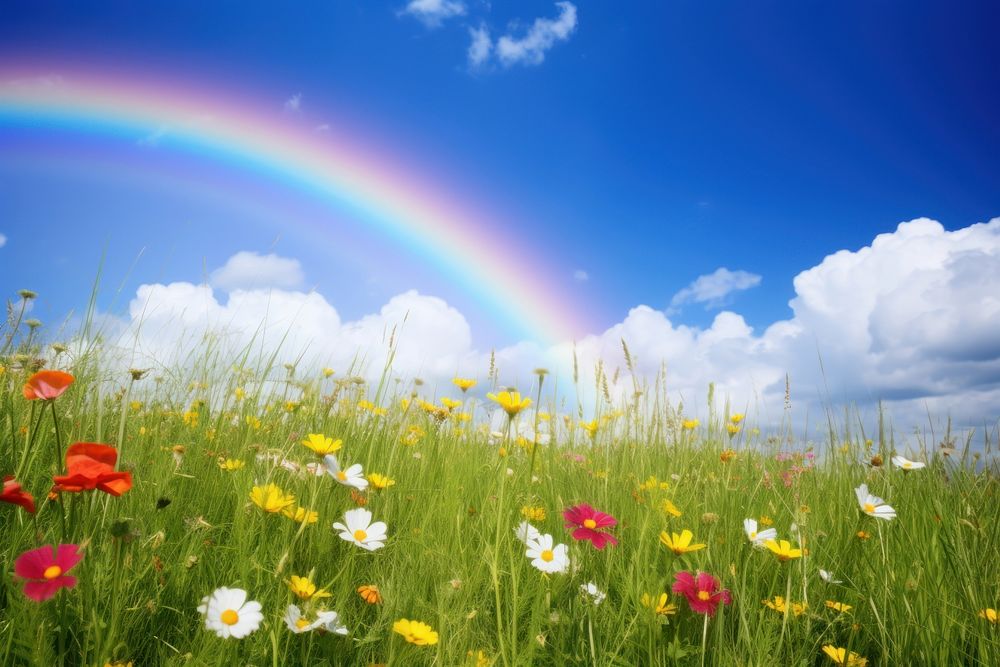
[0,302,1000,667]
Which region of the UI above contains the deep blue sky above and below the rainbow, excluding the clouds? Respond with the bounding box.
[0,0,1000,428]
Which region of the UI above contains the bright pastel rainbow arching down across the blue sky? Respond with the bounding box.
[0,68,587,345]
